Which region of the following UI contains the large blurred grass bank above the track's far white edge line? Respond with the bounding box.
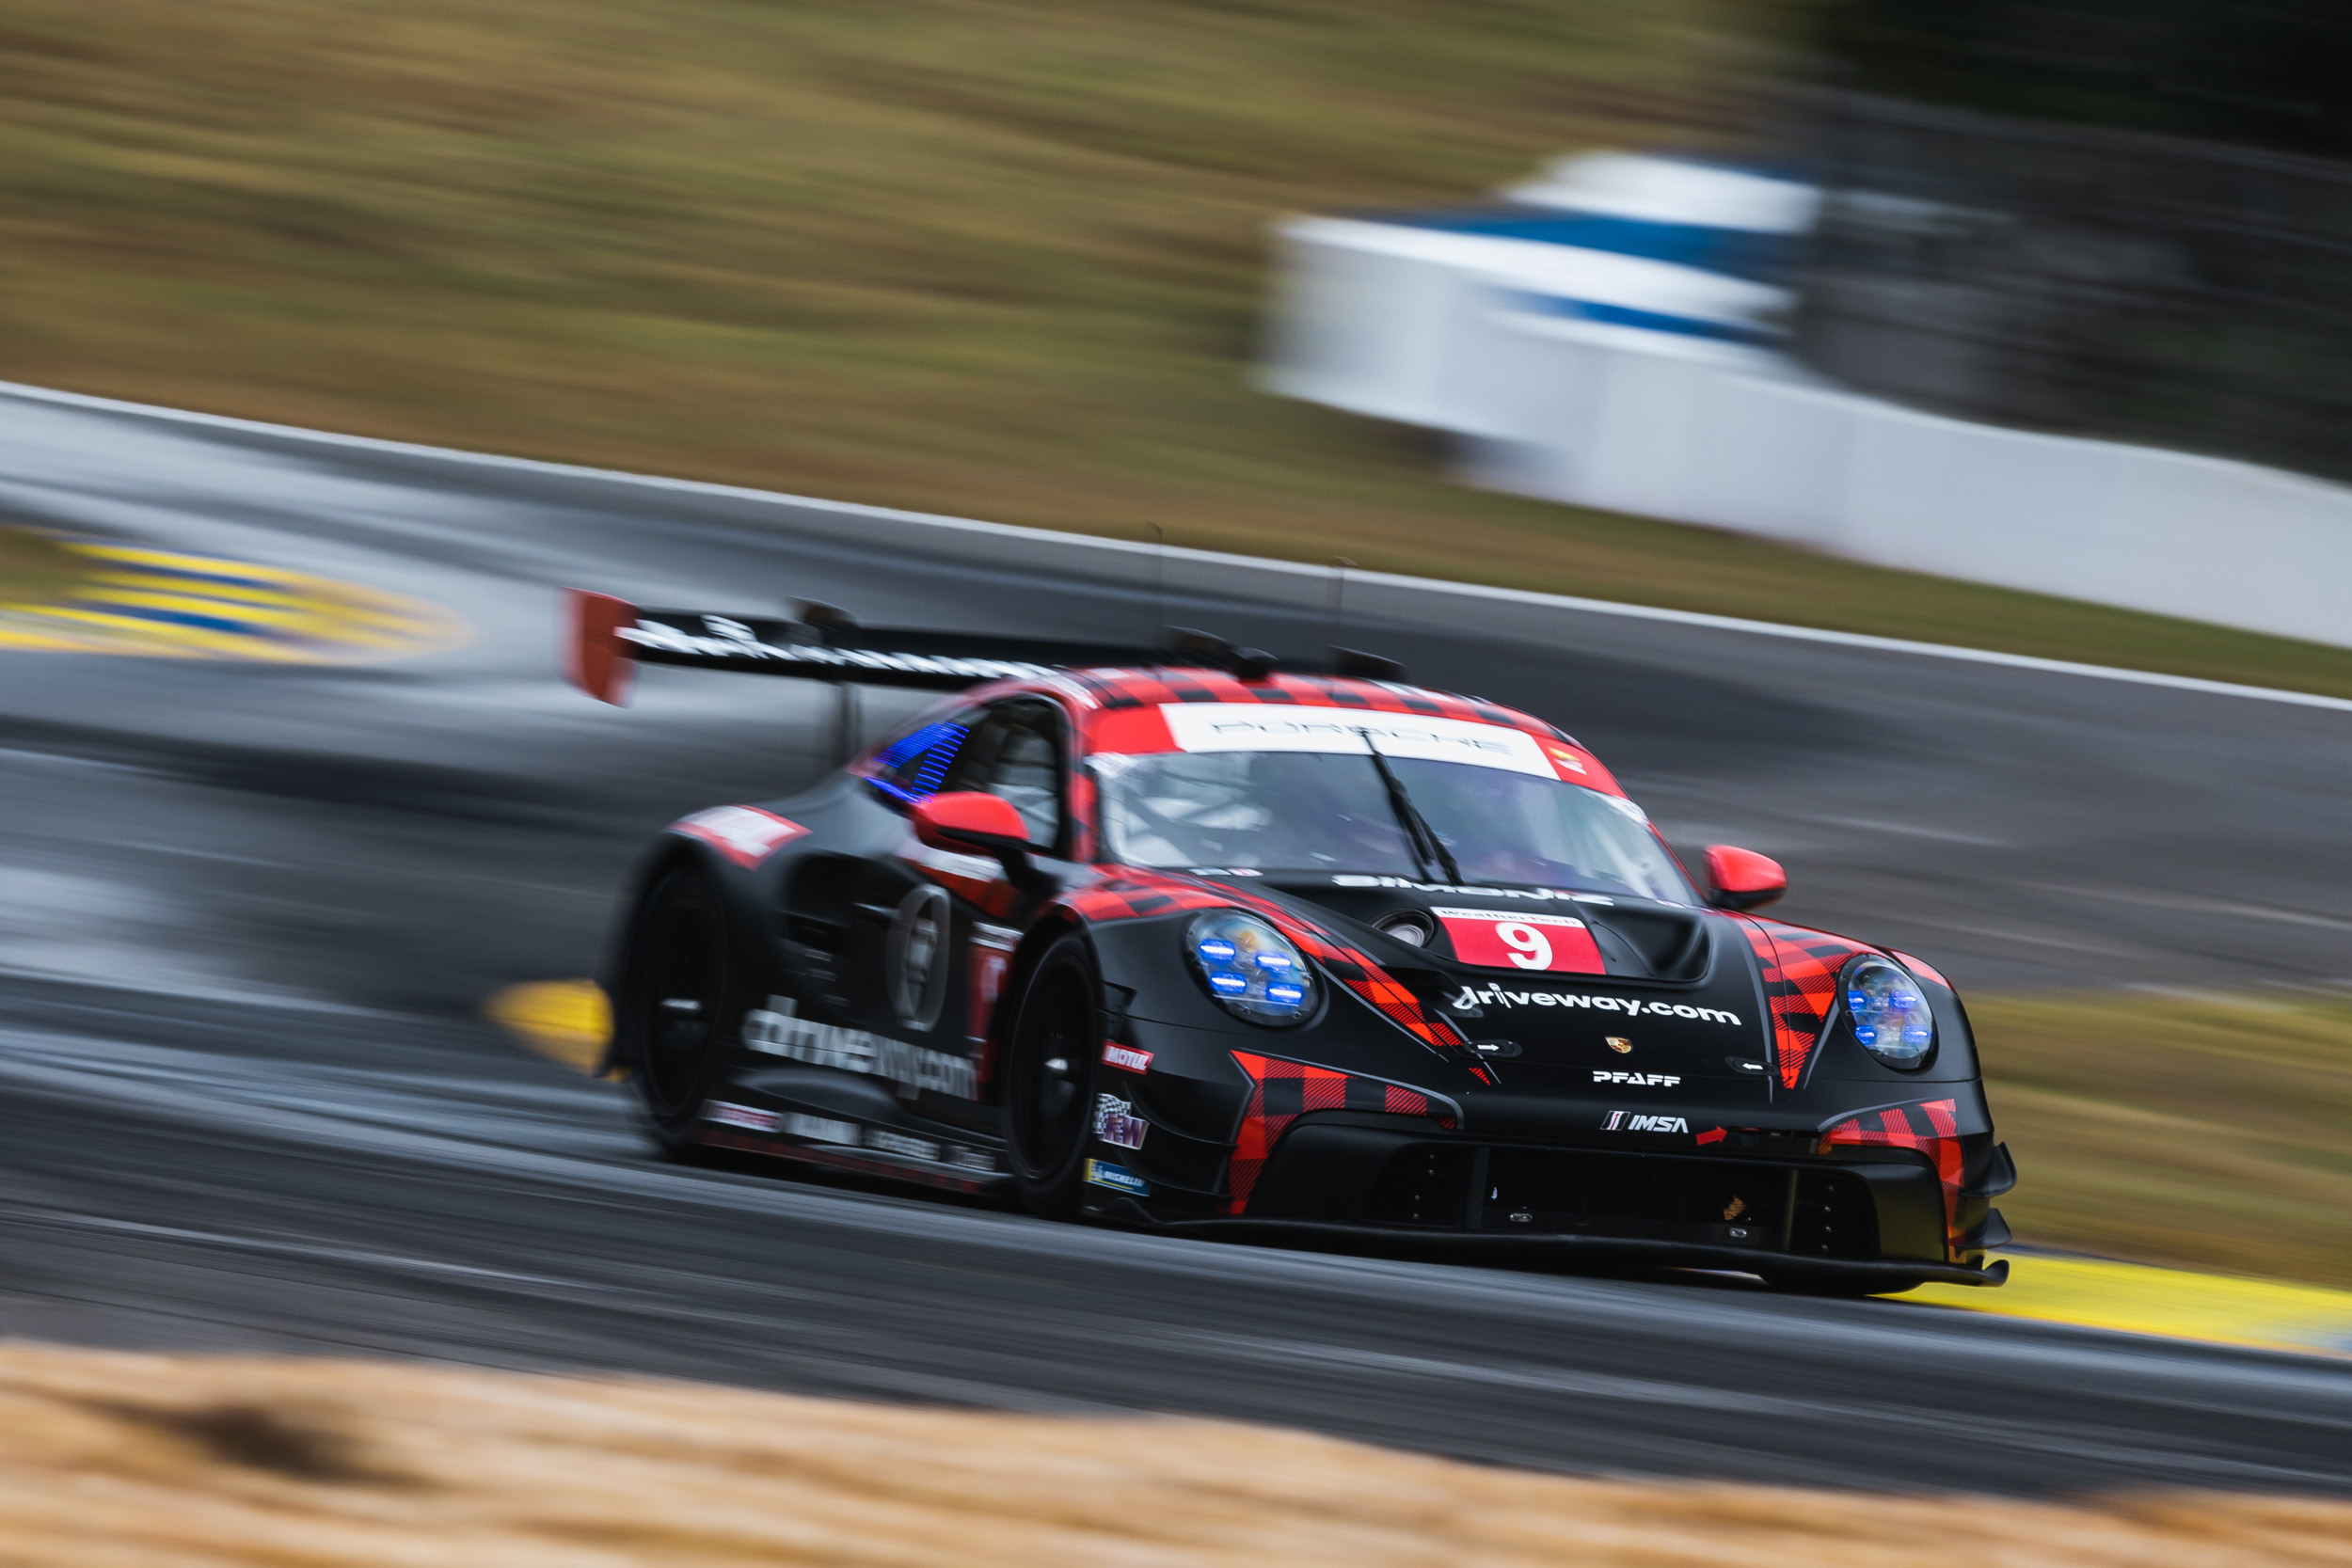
[0,0,2352,693]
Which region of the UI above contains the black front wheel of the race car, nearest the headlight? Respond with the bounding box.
[1005,931,1104,1220]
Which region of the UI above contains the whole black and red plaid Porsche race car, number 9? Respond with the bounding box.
[569,593,2016,1293]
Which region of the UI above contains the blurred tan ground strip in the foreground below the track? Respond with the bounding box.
[0,1347,2352,1568]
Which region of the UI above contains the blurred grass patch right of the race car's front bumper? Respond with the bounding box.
[1969,992,2352,1286]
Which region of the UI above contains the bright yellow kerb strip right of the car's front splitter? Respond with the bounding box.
[1891,1258,2352,1356]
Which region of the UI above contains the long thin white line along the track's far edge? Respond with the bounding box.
[18,381,2352,712]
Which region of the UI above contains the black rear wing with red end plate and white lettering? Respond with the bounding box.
[564,588,1275,703]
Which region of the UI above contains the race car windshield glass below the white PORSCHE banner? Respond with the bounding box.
[1094,752,1692,903]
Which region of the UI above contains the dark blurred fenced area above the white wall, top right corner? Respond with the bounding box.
[1797,0,2352,480]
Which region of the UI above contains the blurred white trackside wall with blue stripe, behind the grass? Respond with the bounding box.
[1265,154,2352,646]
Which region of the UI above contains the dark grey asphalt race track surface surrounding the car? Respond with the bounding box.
[0,397,2352,1493]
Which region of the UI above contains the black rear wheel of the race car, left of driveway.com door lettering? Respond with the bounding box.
[614,863,739,1164]
